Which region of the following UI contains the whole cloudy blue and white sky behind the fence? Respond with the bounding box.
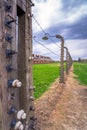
[32,0,87,60]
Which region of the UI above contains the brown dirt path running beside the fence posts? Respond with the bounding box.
[35,68,87,130]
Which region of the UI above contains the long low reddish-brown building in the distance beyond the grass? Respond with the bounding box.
[32,54,54,64]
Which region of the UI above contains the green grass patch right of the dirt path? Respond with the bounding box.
[74,62,87,85]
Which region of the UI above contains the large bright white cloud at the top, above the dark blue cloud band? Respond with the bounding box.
[33,0,87,32]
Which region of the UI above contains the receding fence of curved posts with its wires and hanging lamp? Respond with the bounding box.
[32,15,73,83]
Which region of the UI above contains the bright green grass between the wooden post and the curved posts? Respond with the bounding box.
[33,63,59,98]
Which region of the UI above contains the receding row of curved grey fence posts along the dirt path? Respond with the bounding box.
[57,35,73,83]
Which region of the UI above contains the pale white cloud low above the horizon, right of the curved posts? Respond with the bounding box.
[65,39,87,59]
